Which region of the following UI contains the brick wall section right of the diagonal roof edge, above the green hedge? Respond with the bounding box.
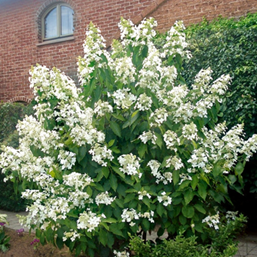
[150,0,257,32]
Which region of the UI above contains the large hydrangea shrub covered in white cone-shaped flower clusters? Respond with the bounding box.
[0,19,257,256]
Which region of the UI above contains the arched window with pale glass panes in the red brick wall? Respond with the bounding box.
[42,3,74,40]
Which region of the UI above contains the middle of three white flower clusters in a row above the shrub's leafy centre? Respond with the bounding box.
[112,88,137,109]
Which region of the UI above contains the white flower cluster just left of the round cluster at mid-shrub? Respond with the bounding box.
[89,144,114,166]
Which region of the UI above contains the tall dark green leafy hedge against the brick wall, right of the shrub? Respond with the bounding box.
[183,13,257,137]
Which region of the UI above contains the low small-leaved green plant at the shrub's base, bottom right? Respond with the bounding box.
[129,212,243,257]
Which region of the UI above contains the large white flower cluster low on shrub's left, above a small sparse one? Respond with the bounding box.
[77,210,106,232]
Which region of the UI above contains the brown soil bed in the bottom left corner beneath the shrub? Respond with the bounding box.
[0,228,74,257]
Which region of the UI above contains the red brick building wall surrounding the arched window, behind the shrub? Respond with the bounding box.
[0,0,257,102]
